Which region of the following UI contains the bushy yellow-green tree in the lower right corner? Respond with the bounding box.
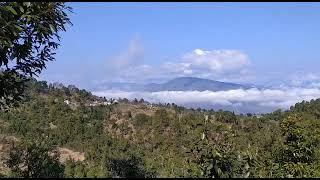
[276,113,319,177]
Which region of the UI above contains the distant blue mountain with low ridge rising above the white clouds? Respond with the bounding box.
[96,77,253,92]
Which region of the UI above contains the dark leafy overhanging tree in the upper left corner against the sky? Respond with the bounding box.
[0,2,71,109]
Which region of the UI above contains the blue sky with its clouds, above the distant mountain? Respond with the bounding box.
[40,2,320,89]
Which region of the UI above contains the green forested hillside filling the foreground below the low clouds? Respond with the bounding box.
[0,80,320,178]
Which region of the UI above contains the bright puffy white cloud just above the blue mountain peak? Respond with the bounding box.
[156,49,250,81]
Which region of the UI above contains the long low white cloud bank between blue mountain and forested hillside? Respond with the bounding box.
[94,88,320,112]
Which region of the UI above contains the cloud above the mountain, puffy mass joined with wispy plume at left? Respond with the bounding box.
[99,47,250,82]
